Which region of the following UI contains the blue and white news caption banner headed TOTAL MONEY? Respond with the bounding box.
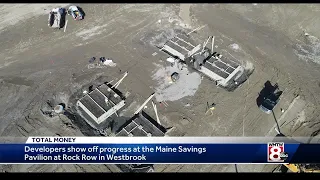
[0,137,320,164]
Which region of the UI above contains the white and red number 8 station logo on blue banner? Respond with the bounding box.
[268,142,288,162]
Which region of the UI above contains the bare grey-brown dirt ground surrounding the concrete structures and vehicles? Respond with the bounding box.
[0,4,320,172]
